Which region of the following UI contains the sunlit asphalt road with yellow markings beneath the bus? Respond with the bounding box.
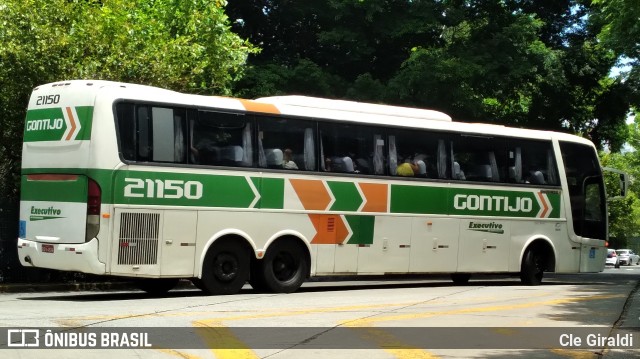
[0,266,640,359]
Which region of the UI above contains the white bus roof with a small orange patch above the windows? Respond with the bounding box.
[35,80,592,144]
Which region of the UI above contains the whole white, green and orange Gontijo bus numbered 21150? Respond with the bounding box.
[18,80,607,294]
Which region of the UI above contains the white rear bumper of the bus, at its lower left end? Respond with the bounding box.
[18,238,106,274]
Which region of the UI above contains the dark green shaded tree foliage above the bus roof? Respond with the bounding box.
[228,0,632,151]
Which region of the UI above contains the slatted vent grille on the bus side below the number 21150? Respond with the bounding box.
[118,213,160,265]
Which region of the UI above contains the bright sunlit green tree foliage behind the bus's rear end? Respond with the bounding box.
[0,0,255,200]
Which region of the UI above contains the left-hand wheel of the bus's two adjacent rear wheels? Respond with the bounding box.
[200,239,250,295]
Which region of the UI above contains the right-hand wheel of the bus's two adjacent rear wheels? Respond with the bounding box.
[256,238,309,293]
